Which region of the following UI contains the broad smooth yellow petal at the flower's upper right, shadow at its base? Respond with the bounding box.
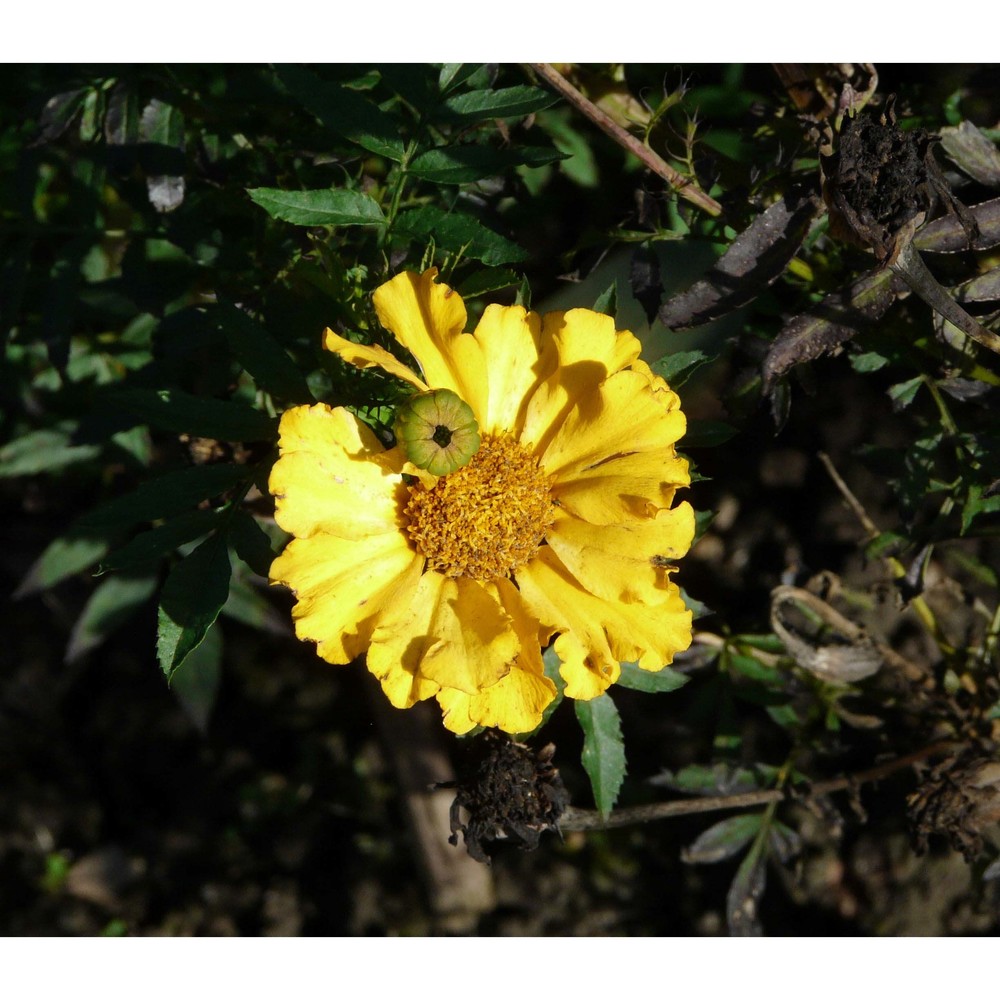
[540,370,687,479]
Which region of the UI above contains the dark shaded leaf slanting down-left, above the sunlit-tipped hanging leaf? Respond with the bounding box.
[77,465,249,536]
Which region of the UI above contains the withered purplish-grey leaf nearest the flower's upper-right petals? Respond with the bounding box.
[659,187,819,330]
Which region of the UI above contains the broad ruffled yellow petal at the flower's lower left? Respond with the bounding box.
[271,533,433,668]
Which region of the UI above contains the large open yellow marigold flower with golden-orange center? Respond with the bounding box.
[270,269,694,733]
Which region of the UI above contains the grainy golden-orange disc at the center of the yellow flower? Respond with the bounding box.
[406,435,553,580]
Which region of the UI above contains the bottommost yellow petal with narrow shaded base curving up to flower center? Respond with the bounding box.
[437,580,556,733]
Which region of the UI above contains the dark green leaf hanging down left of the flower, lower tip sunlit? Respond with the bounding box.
[156,532,231,681]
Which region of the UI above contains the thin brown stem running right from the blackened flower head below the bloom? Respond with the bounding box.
[559,741,953,833]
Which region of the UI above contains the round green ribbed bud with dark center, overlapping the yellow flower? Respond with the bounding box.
[394,389,479,476]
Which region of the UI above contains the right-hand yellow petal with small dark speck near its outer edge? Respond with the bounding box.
[546,503,694,605]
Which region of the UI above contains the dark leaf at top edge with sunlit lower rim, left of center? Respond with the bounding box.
[278,66,406,160]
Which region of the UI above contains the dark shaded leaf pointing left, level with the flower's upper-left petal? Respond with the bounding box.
[106,389,278,441]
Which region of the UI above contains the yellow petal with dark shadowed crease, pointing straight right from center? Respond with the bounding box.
[552,446,691,524]
